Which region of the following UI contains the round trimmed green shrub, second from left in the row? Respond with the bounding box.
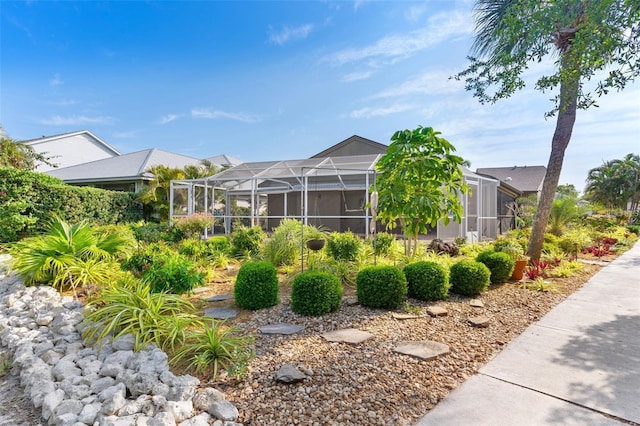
[291,271,342,315]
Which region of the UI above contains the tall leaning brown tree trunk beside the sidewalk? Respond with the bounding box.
[527,50,580,260]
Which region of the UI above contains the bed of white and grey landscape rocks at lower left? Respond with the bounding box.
[0,262,244,426]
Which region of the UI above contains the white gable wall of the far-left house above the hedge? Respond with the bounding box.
[29,134,116,172]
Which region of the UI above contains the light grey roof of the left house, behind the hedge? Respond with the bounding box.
[47,148,201,183]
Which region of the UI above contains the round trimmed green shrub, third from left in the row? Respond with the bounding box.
[356,265,407,309]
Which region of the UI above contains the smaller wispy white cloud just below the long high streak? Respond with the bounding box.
[373,71,464,98]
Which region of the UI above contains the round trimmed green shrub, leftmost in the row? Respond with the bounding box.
[233,262,280,310]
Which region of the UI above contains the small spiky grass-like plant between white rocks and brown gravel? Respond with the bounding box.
[171,320,254,380]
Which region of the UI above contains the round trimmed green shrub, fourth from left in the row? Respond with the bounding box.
[402,261,449,300]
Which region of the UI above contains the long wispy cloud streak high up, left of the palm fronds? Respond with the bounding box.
[324,11,473,66]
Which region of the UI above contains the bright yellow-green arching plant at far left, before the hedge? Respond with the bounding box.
[10,217,133,290]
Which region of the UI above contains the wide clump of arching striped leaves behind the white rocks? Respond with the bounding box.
[82,275,202,350]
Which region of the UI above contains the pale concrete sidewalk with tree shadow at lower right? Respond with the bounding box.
[415,242,640,426]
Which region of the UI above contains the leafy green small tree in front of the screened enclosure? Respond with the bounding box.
[376,126,468,254]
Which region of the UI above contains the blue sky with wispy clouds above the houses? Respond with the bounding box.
[0,0,640,189]
